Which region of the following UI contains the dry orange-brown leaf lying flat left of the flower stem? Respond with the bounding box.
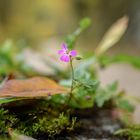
[0,77,69,98]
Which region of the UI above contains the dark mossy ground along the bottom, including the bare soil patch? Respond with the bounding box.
[0,100,140,140]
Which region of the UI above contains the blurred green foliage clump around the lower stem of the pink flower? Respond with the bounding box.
[52,57,99,108]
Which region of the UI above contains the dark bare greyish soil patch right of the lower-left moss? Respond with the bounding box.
[38,109,127,140]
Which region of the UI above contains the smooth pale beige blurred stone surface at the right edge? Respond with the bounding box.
[98,64,140,123]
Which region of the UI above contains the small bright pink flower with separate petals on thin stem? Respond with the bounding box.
[58,43,77,62]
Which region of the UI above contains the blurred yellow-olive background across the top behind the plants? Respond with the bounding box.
[0,0,140,54]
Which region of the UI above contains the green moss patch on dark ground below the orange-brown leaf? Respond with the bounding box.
[0,102,76,137]
